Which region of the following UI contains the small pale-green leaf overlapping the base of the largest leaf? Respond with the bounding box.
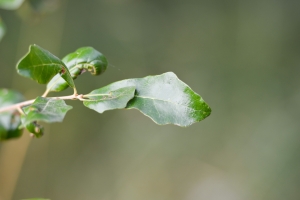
[83,86,135,113]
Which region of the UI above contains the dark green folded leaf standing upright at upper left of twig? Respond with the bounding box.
[17,44,75,88]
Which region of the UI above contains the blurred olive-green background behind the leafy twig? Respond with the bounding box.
[0,0,300,200]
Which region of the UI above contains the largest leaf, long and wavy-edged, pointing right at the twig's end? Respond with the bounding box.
[89,72,211,126]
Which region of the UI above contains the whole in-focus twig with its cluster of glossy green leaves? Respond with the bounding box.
[0,45,211,140]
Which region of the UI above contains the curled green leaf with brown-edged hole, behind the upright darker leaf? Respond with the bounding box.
[47,47,107,92]
